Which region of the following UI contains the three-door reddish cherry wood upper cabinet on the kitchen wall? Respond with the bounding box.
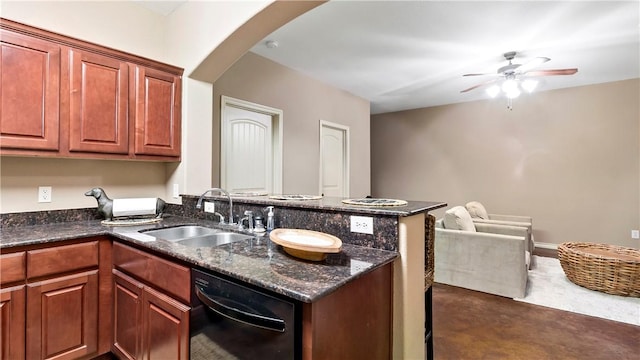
[0,18,183,161]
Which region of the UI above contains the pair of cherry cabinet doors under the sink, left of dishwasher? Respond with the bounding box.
[112,270,190,360]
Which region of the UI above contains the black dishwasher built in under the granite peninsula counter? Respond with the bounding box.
[189,269,302,360]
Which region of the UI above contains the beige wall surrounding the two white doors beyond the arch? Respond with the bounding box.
[213,52,371,197]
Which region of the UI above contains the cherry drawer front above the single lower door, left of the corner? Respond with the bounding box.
[27,241,98,278]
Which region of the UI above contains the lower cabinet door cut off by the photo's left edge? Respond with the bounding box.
[0,285,25,359]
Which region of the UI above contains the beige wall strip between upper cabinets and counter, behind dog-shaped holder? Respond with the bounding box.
[0,157,166,213]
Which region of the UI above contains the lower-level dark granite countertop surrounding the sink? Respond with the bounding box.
[0,216,398,302]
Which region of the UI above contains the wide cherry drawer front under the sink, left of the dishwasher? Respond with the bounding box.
[113,243,191,304]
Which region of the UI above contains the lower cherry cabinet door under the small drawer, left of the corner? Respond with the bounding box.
[27,270,98,359]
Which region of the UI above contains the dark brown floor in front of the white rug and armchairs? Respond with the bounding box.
[433,284,640,360]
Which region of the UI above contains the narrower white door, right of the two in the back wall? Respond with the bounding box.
[320,120,349,197]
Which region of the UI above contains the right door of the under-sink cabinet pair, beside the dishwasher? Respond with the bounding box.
[142,287,189,360]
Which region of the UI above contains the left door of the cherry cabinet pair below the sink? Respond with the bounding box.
[111,270,142,359]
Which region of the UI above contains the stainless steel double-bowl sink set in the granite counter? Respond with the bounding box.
[141,225,251,247]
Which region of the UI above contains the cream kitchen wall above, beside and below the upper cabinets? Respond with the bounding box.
[0,0,280,213]
